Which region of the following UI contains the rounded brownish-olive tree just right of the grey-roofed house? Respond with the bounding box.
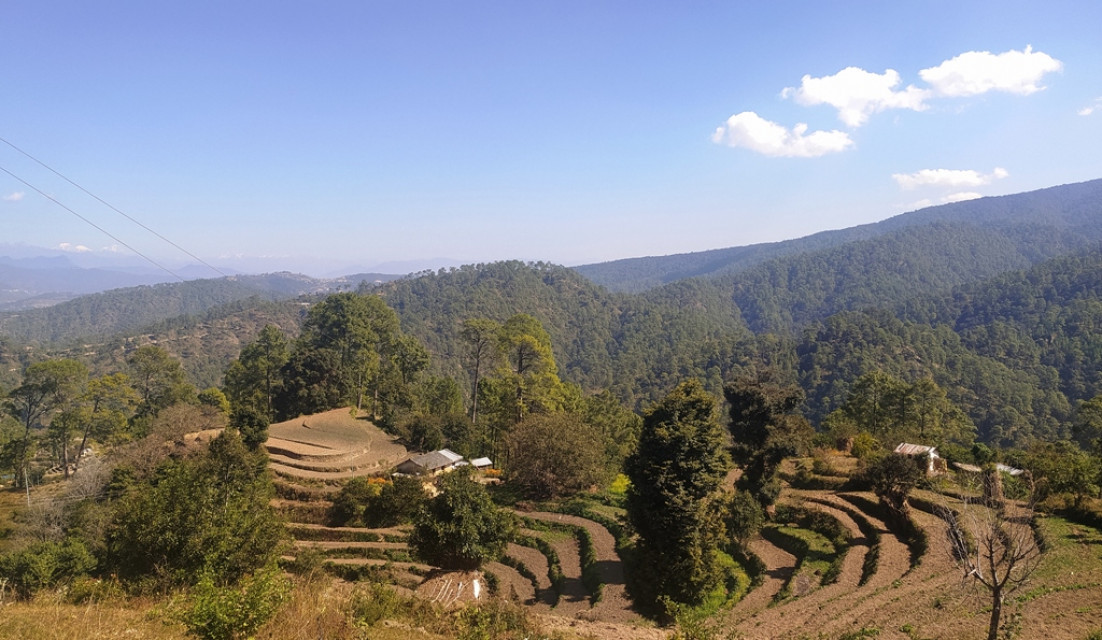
[507,413,606,500]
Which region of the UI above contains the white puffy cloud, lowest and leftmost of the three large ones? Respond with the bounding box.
[712,111,853,158]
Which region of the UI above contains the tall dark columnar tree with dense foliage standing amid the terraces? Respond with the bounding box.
[626,380,731,606]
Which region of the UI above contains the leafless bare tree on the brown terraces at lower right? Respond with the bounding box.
[941,468,1042,640]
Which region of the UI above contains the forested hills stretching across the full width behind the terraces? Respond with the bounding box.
[0,182,1102,443]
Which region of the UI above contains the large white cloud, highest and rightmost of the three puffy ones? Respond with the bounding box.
[918,46,1063,97]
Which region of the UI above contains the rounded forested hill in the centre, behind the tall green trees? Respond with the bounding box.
[380,262,750,404]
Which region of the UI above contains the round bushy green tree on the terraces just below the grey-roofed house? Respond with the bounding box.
[409,470,515,571]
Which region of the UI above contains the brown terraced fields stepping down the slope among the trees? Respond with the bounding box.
[269,412,1102,640]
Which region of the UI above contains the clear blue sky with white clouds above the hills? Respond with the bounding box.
[0,0,1102,275]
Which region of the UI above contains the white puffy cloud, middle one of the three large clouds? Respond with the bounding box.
[780,67,928,127]
